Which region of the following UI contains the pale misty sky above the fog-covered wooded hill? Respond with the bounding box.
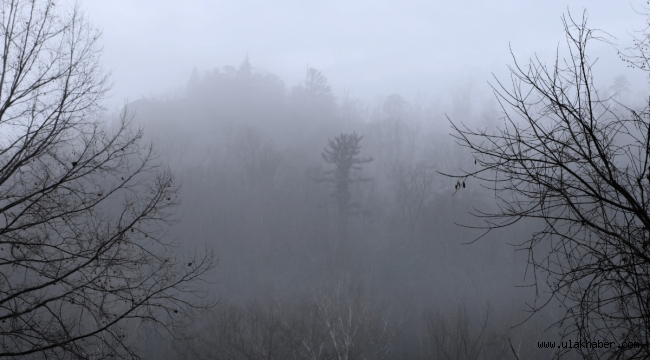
[82,0,646,105]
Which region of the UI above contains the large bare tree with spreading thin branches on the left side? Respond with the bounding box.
[0,0,214,359]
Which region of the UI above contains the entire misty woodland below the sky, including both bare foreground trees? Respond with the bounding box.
[0,0,650,360]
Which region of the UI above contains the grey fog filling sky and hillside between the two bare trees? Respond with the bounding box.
[40,0,648,359]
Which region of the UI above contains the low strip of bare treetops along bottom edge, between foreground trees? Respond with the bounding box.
[177,274,551,359]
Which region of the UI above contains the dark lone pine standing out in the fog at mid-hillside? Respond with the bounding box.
[321,132,374,239]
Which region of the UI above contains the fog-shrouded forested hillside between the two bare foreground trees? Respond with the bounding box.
[126,58,554,358]
